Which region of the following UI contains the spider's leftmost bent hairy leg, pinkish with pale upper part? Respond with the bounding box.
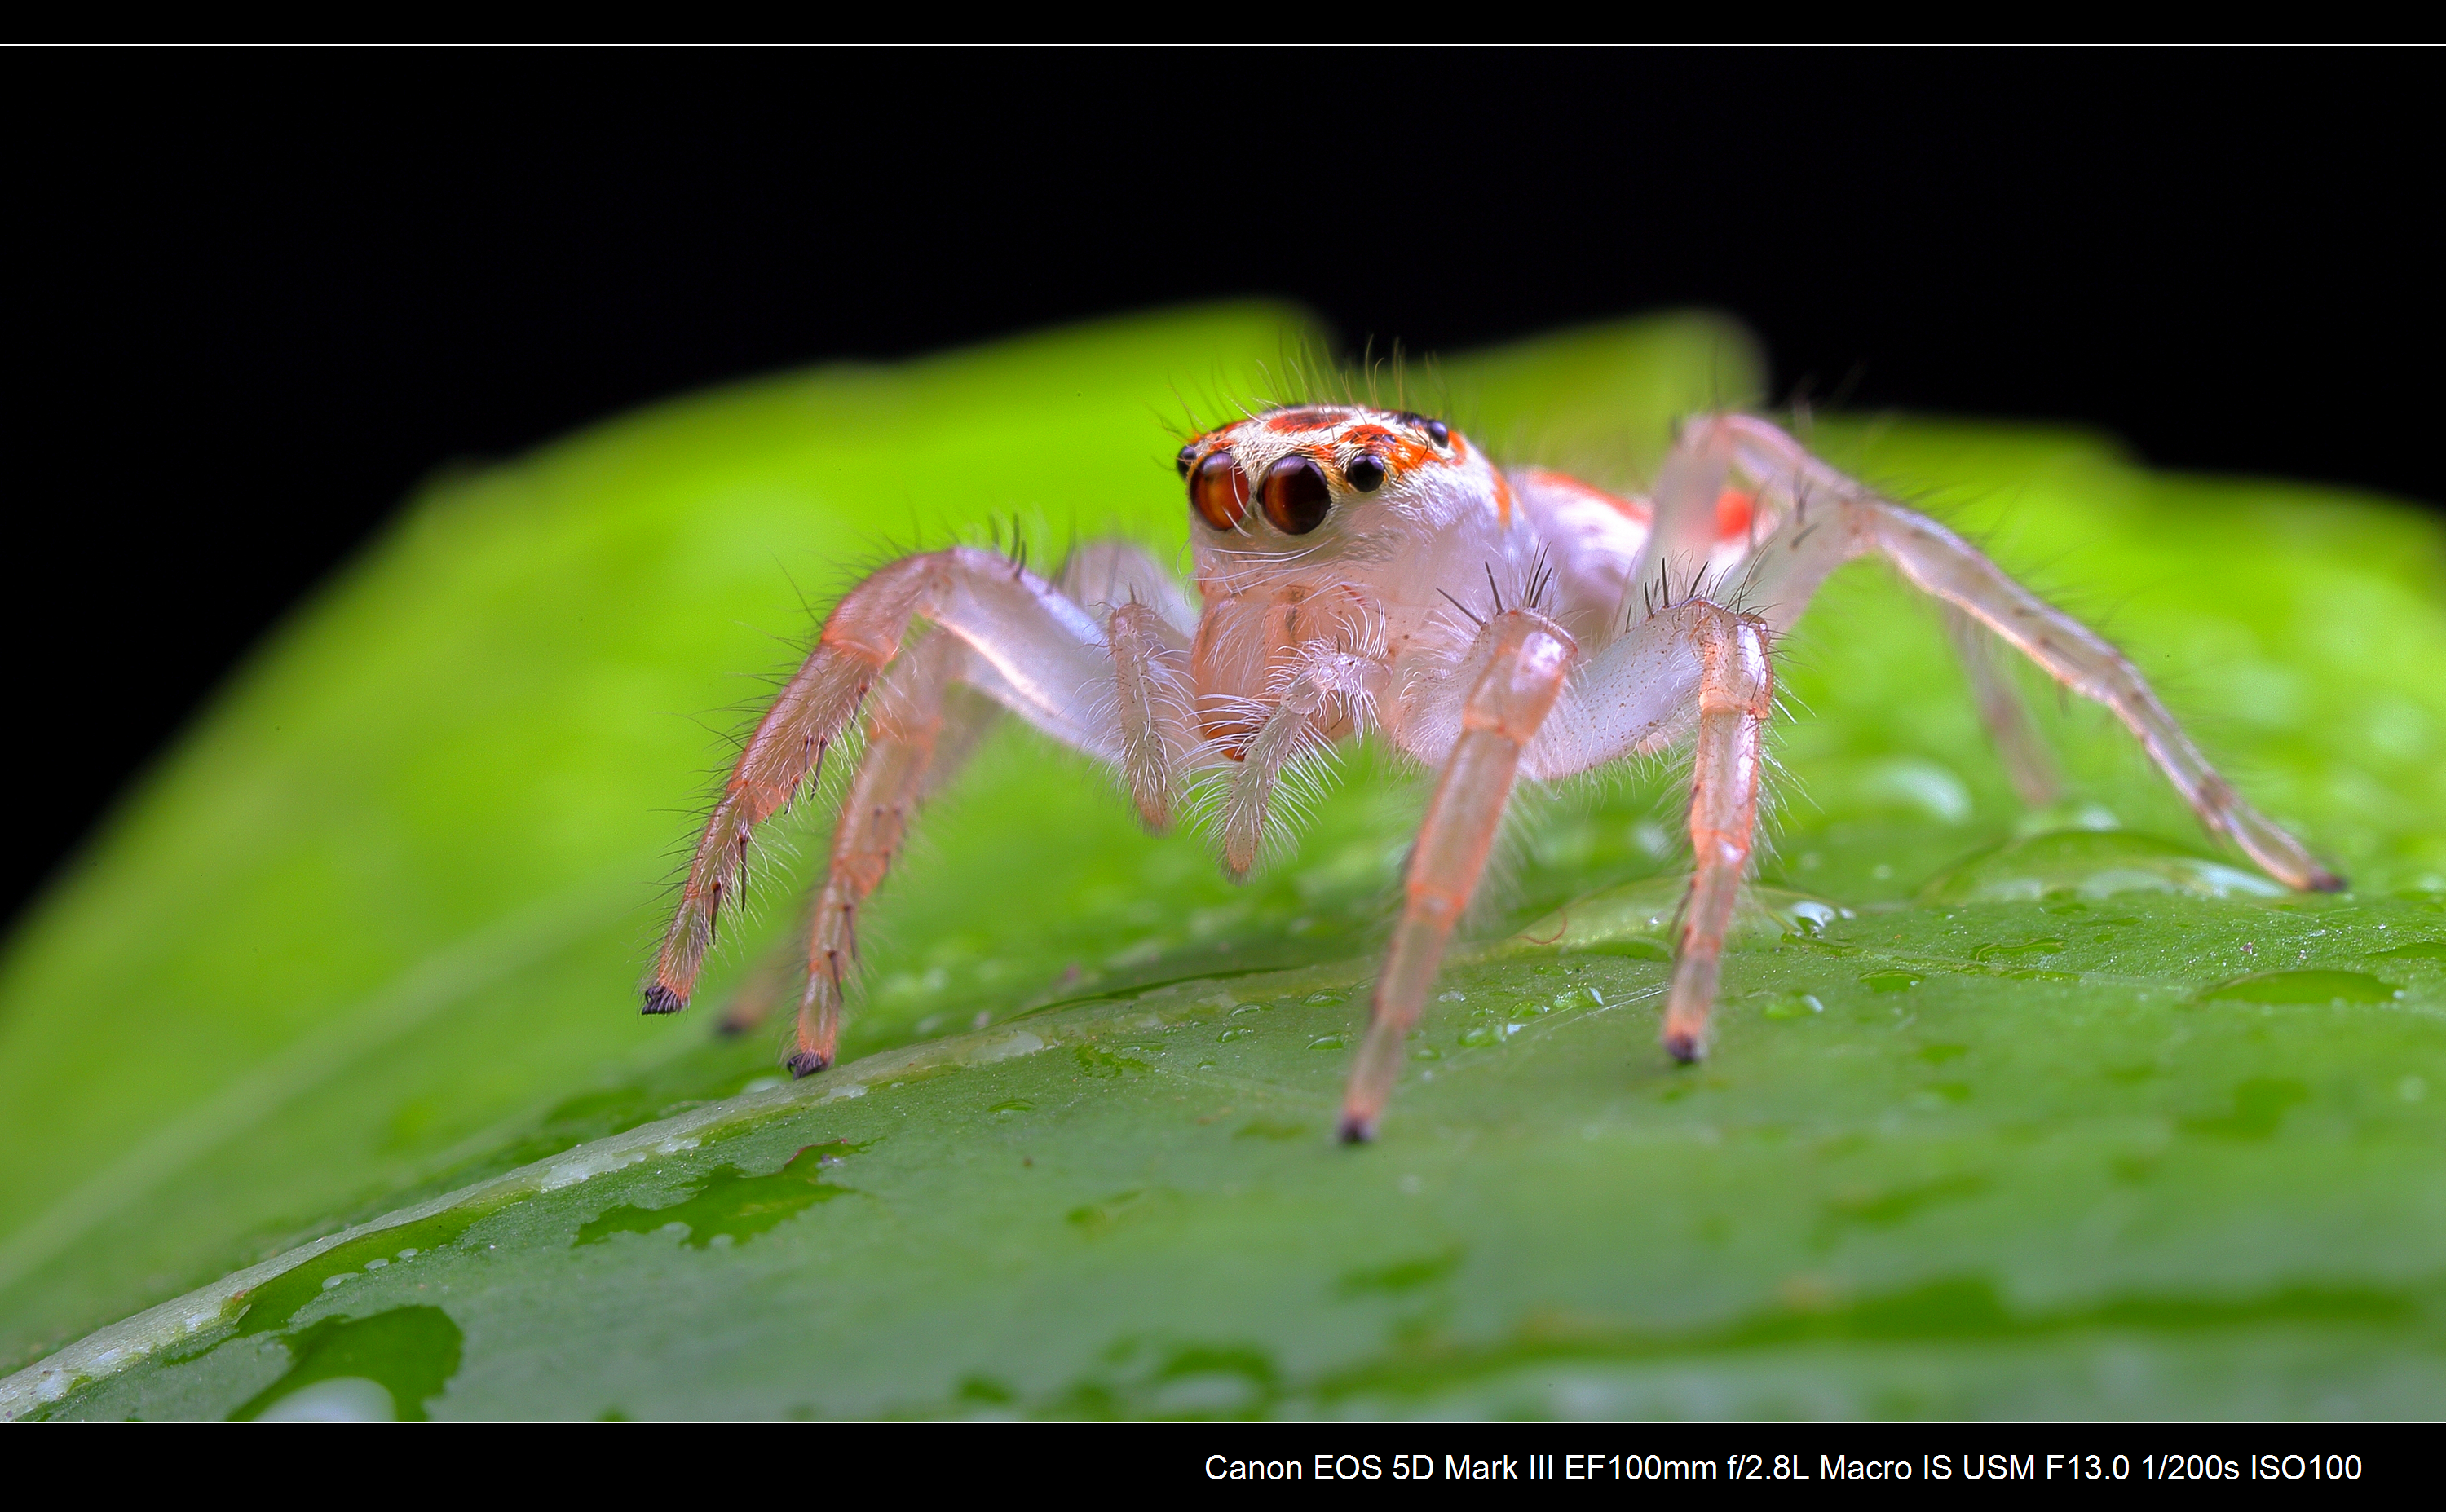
[643,545,1145,1013]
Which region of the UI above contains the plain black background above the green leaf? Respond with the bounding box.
[0,42,2446,929]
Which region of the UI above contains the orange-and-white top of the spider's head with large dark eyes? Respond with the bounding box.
[1179,403,1497,550]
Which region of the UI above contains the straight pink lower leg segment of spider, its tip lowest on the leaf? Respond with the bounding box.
[1340,609,1575,1143]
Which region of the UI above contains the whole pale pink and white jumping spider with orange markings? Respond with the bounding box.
[646,403,2343,1140]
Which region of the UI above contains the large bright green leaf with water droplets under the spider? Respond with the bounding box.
[0,311,2446,1417]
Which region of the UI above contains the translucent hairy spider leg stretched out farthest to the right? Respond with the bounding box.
[1685,416,2343,893]
